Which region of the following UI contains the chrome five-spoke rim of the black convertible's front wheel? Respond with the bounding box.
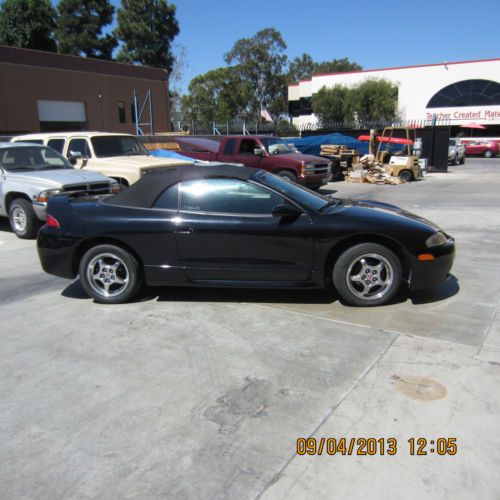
[346,253,394,300]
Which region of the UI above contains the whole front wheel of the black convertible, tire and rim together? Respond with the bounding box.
[332,243,403,307]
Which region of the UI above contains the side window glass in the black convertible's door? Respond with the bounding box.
[180,179,284,216]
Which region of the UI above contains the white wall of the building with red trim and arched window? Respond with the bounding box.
[289,59,500,125]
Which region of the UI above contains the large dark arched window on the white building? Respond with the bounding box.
[427,80,500,108]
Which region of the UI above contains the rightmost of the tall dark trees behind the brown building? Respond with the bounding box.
[115,0,179,72]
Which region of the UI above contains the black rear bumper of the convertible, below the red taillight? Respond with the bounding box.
[37,226,77,279]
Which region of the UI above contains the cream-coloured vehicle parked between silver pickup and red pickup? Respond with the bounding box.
[11,132,192,186]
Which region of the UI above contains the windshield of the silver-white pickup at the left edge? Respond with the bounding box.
[0,146,73,172]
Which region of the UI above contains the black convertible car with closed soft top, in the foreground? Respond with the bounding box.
[38,165,455,306]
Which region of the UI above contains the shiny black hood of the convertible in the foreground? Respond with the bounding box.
[332,199,442,231]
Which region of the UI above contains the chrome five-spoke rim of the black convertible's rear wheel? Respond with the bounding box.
[87,253,130,297]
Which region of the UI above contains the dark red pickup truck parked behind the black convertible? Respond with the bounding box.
[169,135,332,189]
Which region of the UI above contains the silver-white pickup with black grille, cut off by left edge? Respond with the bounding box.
[0,142,120,238]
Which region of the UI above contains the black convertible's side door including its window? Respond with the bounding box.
[175,178,314,282]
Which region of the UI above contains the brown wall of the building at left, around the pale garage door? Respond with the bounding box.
[0,47,170,134]
